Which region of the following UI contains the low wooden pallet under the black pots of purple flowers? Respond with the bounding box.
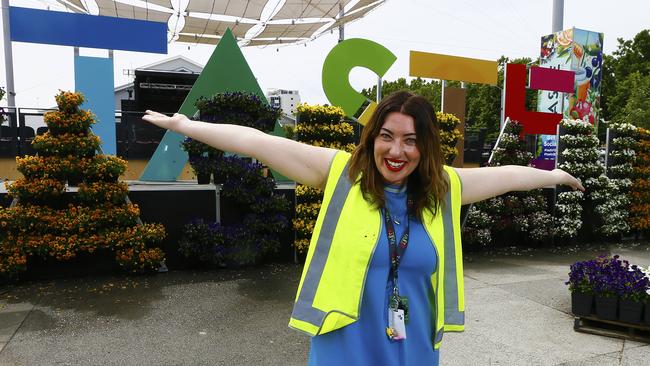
[573,316,650,343]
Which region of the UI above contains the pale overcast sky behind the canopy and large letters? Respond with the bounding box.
[0,0,650,107]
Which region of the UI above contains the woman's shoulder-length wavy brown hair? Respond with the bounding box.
[348,91,449,221]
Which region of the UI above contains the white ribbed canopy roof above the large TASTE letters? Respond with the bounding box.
[56,0,386,46]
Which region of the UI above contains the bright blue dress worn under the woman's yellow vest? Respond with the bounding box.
[308,185,438,366]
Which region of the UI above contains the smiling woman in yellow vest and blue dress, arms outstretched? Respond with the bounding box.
[143,92,584,365]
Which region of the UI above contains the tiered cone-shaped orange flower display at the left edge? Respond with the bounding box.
[0,92,166,275]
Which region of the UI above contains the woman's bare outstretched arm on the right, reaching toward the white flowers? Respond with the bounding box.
[456,165,585,205]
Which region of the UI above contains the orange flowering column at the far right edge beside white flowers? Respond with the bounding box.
[628,128,650,231]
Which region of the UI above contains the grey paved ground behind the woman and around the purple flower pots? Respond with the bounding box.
[0,244,650,366]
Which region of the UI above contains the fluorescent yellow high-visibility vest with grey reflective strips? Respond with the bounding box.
[289,152,465,349]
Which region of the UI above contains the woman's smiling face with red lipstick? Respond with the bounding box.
[374,112,420,185]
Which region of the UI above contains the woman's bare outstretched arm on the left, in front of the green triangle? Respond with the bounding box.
[142,111,337,188]
